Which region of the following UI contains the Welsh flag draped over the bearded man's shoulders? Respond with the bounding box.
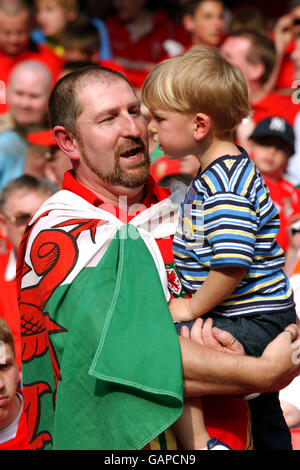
[17,183,182,450]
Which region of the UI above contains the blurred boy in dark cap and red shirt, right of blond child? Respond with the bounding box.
[250,116,300,251]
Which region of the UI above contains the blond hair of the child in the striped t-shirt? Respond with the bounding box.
[142,46,250,134]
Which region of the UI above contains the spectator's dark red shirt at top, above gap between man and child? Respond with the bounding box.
[106,0,187,86]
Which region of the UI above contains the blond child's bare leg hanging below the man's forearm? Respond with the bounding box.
[173,398,210,450]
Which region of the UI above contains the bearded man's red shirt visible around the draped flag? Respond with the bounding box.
[63,171,251,450]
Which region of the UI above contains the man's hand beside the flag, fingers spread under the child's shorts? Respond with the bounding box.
[181,318,245,354]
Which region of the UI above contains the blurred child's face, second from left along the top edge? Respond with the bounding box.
[36,0,72,37]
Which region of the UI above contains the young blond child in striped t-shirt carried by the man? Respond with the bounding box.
[142,47,296,450]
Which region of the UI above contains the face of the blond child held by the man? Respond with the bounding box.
[148,109,196,159]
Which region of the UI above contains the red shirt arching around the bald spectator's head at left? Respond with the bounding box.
[0,44,63,114]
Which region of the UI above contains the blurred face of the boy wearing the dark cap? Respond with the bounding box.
[251,137,289,180]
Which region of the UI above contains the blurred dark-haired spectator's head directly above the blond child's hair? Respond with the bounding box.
[182,0,226,47]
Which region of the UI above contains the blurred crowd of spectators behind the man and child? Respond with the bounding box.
[0,0,300,448]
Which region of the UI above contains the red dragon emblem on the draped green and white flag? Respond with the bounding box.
[17,212,100,449]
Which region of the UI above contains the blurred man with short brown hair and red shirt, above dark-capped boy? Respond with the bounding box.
[220,31,299,135]
